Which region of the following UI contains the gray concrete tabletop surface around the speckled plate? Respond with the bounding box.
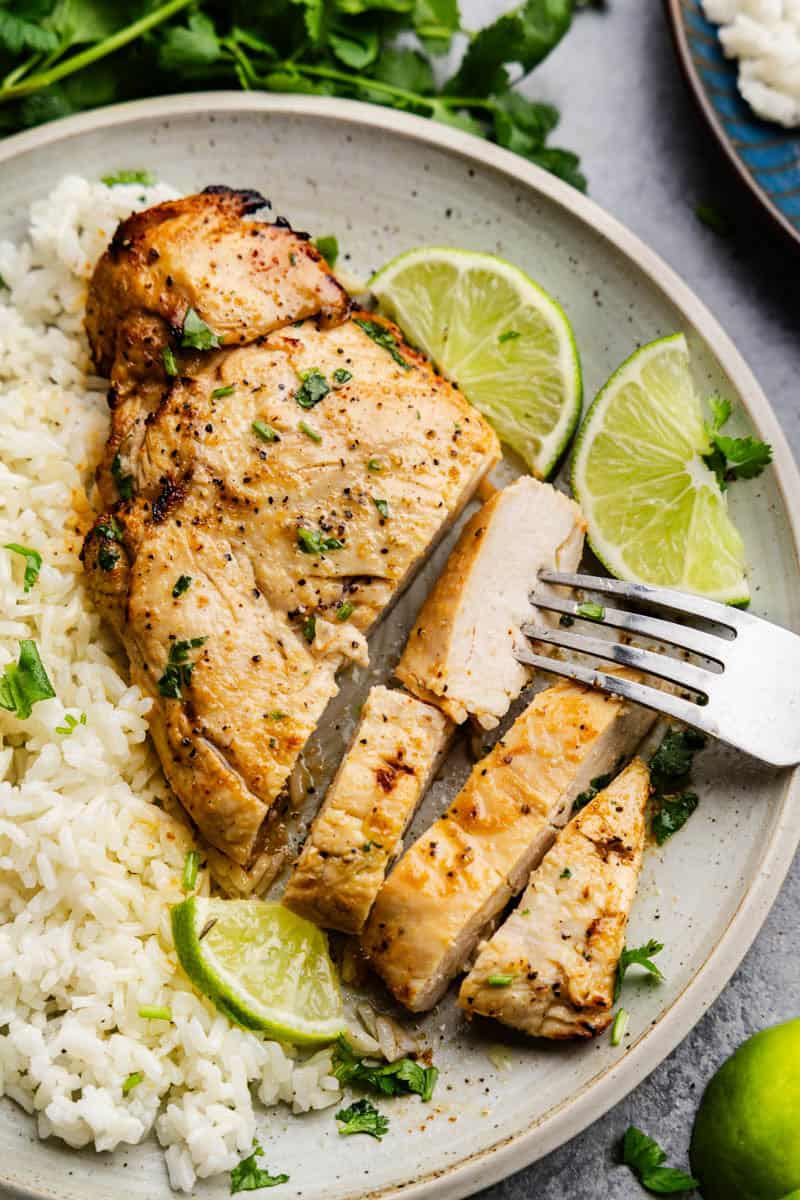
[464,0,800,1200]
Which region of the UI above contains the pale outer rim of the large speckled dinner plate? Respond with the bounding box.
[0,93,800,1200]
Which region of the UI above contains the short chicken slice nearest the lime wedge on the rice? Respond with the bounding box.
[283,686,453,934]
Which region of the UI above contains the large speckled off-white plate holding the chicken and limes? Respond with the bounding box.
[0,92,800,1200]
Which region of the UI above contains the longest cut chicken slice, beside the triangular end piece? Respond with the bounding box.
[362,680,655,1013]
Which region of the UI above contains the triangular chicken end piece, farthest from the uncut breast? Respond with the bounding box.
[458,758,650,1038]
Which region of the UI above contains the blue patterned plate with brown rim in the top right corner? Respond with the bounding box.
[666,0,800,242]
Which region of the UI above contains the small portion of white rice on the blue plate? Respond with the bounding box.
[703,0,800,128]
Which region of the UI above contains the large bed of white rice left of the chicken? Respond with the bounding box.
[0,178,339,1190]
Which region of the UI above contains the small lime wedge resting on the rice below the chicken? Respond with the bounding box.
[172,896,344,1045]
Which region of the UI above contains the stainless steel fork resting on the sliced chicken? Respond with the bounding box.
[517,571,800,767]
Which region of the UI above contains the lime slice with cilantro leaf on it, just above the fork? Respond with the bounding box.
[572,334,750,604]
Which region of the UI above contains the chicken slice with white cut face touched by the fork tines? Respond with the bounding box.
[396,475,585,730]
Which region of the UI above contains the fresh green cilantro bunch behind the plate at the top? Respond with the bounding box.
[0,0,585,190]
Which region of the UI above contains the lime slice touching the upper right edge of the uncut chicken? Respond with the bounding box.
[369,246,582,479]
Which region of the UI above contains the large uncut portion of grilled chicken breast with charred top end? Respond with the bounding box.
[84,193,499,866]
